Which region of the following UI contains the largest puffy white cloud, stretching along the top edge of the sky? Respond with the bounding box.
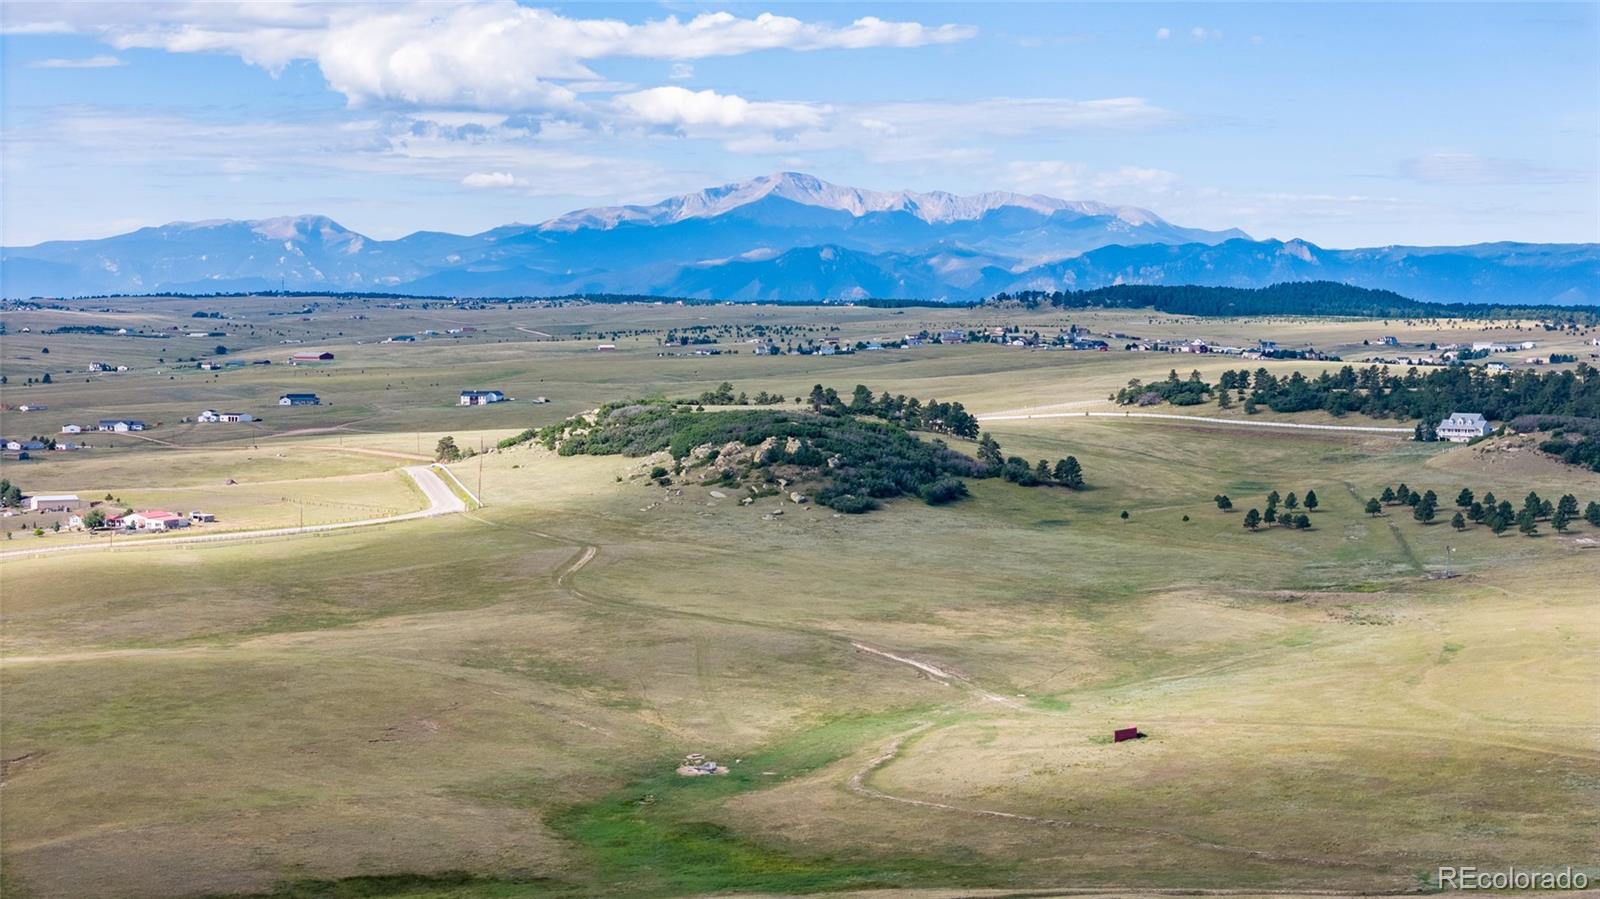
[8,0,976,110]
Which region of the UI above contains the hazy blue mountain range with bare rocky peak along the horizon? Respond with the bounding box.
[0,173,1600,304]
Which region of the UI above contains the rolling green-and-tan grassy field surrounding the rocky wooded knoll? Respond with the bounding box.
[0,301,1600,897]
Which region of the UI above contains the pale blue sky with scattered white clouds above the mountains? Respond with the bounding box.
[0,0,1600,246]
